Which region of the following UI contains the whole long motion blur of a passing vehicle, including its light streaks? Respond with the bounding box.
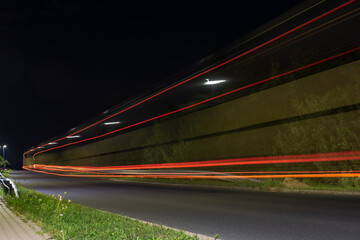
[23,0,360,178]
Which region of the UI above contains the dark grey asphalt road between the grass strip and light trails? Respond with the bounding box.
[10,171,360,240]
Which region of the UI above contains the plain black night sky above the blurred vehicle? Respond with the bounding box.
[0,0,301,167]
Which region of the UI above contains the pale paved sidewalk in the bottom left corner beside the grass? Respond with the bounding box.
[0,197,48,240]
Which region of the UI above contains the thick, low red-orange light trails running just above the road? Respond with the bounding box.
[23,151,360,179]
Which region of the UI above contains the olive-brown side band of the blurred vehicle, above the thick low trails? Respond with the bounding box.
[26,61,360,166]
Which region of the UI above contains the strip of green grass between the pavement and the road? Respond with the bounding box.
[5,186,198,240]
